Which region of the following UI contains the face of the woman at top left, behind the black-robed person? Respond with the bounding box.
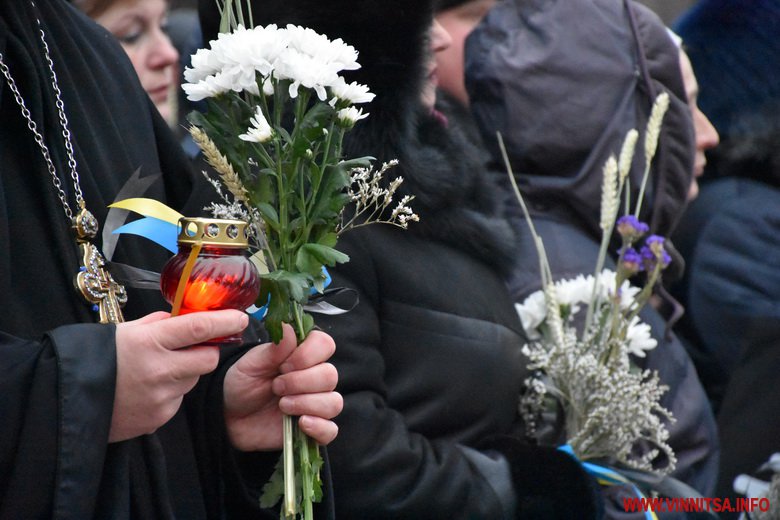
[95,0,179,124]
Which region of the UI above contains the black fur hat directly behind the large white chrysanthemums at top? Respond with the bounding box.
[198,0,433,160]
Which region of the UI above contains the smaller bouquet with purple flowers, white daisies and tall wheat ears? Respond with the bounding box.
[499,94,676,480]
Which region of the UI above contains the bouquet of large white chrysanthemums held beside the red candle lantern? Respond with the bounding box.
[183,0,417,518]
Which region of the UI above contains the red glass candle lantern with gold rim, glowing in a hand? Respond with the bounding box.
[160,217,260,345]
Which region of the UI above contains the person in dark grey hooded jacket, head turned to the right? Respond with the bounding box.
[464,0,718,509]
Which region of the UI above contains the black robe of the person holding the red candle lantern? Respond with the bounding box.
[0,0,302,520]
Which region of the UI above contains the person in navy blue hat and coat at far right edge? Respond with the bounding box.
[676,0,780,386]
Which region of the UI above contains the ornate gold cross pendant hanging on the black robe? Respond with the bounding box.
[73,208,127,323]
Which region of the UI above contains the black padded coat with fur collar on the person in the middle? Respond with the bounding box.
[317,106,596,519]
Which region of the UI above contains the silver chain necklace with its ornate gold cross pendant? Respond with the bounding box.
[0,0,127,323]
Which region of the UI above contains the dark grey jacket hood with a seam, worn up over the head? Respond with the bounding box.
[466,0,695,239]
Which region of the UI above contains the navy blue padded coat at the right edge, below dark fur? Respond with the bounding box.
[679,177,780,382]
